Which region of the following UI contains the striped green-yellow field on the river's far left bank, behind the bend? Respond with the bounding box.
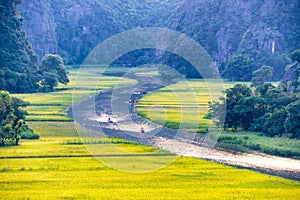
[13,68,135,121]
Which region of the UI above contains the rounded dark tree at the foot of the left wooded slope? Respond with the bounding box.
[39,54,69,91]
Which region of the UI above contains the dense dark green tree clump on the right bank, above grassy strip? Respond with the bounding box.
[210,50,300,139]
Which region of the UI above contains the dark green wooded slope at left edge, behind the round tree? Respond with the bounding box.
[0,0,37,92]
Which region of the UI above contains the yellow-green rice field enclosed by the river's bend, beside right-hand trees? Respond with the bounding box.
[136,80,233,131]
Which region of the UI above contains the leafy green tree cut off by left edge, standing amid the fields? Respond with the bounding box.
[0,91,32,146]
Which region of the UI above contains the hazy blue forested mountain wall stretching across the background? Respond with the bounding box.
[11,0,300,81]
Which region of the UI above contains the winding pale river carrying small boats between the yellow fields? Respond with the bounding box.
[68,73,300,181]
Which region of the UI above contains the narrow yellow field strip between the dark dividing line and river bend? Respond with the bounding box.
[0,138,165,158]
